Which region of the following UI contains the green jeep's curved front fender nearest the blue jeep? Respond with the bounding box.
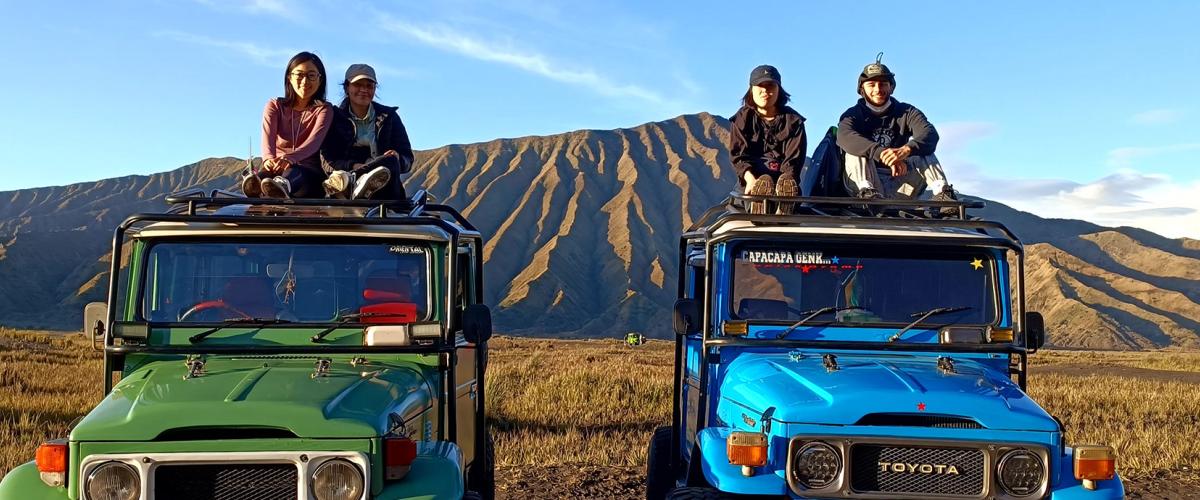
[376,441,466,500]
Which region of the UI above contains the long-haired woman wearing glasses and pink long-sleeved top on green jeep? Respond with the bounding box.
[241,52,332,198]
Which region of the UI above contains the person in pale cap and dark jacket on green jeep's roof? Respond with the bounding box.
[320,64,413,199]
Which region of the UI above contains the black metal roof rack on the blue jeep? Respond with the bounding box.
[682,191,1021,247]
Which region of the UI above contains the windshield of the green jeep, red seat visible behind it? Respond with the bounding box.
[139,239,432,324]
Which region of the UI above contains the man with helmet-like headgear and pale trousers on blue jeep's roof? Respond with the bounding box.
[838,53,958,209]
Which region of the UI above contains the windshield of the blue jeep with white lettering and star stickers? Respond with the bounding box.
[731,245,1000,327]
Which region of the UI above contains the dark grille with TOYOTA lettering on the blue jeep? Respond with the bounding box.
[847,445,985,496]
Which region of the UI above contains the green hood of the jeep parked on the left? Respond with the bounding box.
[71,356,432,441]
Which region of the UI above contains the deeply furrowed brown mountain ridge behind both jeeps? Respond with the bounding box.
[0,113,1200,349]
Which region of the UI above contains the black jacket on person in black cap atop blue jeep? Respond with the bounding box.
[730,106,809,186]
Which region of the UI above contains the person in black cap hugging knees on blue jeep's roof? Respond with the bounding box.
[730,65,809,213]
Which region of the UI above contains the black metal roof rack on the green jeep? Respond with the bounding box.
[160,188,476,231]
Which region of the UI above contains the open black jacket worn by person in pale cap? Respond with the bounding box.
[320,100,413,170]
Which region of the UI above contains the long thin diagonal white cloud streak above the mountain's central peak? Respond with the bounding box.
[383,16,666,103]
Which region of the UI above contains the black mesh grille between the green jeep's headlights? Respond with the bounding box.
[154,464,296,500]
